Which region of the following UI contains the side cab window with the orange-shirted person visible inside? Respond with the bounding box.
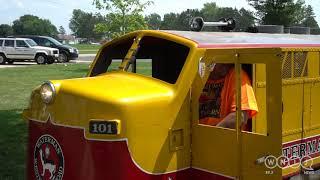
[199,63,266,134]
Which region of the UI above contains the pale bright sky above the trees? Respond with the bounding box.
[0,0,320,32]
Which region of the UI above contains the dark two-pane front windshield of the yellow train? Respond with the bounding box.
[91,36,189,84]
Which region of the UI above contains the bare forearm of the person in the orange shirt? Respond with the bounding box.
[217,111,248,129]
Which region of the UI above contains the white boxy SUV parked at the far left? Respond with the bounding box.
[0,38,59,64]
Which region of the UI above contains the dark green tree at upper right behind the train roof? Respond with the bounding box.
[247,0,304,26]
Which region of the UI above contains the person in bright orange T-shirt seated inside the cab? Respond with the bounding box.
[199,64,258,130]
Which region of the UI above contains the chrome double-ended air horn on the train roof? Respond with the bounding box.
[190,17,236,32]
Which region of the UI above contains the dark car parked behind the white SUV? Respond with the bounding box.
[19,35,79,62]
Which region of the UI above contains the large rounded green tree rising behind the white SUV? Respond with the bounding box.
[12,15,58,37]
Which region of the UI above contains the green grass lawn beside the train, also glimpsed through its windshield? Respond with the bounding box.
[0,62,151,180]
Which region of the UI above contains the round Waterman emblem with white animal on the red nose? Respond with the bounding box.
[33,134,64,180]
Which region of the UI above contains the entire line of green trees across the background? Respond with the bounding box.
[0,0,319,40]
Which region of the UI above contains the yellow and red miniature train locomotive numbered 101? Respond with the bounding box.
[23,30,320,180]
